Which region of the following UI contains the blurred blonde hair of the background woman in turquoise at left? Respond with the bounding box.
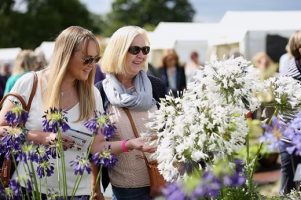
[12,50,38,75]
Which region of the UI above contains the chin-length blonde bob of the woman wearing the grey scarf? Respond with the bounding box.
[101,26,149,74]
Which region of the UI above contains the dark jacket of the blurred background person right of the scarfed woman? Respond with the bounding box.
[160,65,186,96]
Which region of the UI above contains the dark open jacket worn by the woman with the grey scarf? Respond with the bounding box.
[95,74,166,190]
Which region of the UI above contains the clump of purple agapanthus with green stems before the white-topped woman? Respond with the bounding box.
[0,105,117,199]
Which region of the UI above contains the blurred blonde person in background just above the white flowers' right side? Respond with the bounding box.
[252,52,277,80]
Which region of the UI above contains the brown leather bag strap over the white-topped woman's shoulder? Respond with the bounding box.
[0,72,38,112]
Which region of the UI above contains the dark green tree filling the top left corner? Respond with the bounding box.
[0,0,100,48]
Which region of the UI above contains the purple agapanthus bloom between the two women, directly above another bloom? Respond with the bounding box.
[84,111,117,140]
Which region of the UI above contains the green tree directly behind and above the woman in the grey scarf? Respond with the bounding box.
[103,0,195,36]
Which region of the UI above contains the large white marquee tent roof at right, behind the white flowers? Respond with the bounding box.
[209,11,301,59]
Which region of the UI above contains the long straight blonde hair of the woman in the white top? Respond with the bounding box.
[43,26,99,121]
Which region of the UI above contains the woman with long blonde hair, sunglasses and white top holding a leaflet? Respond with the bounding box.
[0,26,103,199]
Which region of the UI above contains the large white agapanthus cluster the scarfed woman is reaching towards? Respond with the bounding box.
[148,58,261,181]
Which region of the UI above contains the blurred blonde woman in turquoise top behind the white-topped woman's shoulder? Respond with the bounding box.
[4,50,38,95]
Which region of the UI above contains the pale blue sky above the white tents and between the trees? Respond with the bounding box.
[80,0,301,22]
